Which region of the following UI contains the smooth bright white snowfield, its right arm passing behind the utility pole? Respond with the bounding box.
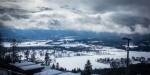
[56,51,150,70]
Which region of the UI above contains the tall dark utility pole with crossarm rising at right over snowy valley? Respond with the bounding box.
[123,37,131,75]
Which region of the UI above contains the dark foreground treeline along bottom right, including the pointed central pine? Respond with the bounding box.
[72,60,150,75]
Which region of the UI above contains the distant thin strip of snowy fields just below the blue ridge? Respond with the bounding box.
[2,39,89,47]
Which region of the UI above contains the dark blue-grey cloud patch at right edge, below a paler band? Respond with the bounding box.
[112,14,150,27]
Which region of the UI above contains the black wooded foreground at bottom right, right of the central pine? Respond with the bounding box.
[92,63,150,75]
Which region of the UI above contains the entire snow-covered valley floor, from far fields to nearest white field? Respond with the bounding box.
[3,39,150,70]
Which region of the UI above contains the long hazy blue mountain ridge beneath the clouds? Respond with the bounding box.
[0,28,150,41]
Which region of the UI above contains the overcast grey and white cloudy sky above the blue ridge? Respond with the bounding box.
[0,0,150,34]
